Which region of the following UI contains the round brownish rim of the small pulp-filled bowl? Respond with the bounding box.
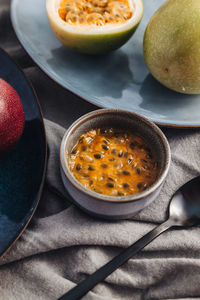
[60,108,171,203]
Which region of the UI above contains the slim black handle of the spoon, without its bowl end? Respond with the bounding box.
[58,219,173,300]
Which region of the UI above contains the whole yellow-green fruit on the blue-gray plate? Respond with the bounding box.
[143,0,200,94]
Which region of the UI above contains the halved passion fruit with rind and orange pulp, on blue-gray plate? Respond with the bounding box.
[46,0,143,54]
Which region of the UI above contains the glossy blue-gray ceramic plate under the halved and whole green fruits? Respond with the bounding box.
[11,0,200,127]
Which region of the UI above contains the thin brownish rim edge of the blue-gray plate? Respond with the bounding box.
[10,0,200,129]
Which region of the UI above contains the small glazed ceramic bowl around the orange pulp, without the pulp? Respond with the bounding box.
[60,109,171,219]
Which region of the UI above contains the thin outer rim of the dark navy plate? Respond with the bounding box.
[0,47,47,259]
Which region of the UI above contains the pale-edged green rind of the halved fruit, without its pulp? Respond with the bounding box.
[46,0,143,54]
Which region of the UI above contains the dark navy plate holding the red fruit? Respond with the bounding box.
[0,49,47,256]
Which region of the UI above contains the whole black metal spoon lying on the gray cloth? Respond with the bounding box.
[58,176,200,300]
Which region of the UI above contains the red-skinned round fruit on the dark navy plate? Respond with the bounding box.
[0,78,25,154]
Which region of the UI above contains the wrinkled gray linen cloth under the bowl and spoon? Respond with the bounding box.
[0,0,200,300]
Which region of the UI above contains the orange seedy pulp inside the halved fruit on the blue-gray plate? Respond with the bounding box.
[58,0,133,26]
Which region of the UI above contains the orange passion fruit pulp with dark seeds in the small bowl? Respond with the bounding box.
[68,128,158,196]
